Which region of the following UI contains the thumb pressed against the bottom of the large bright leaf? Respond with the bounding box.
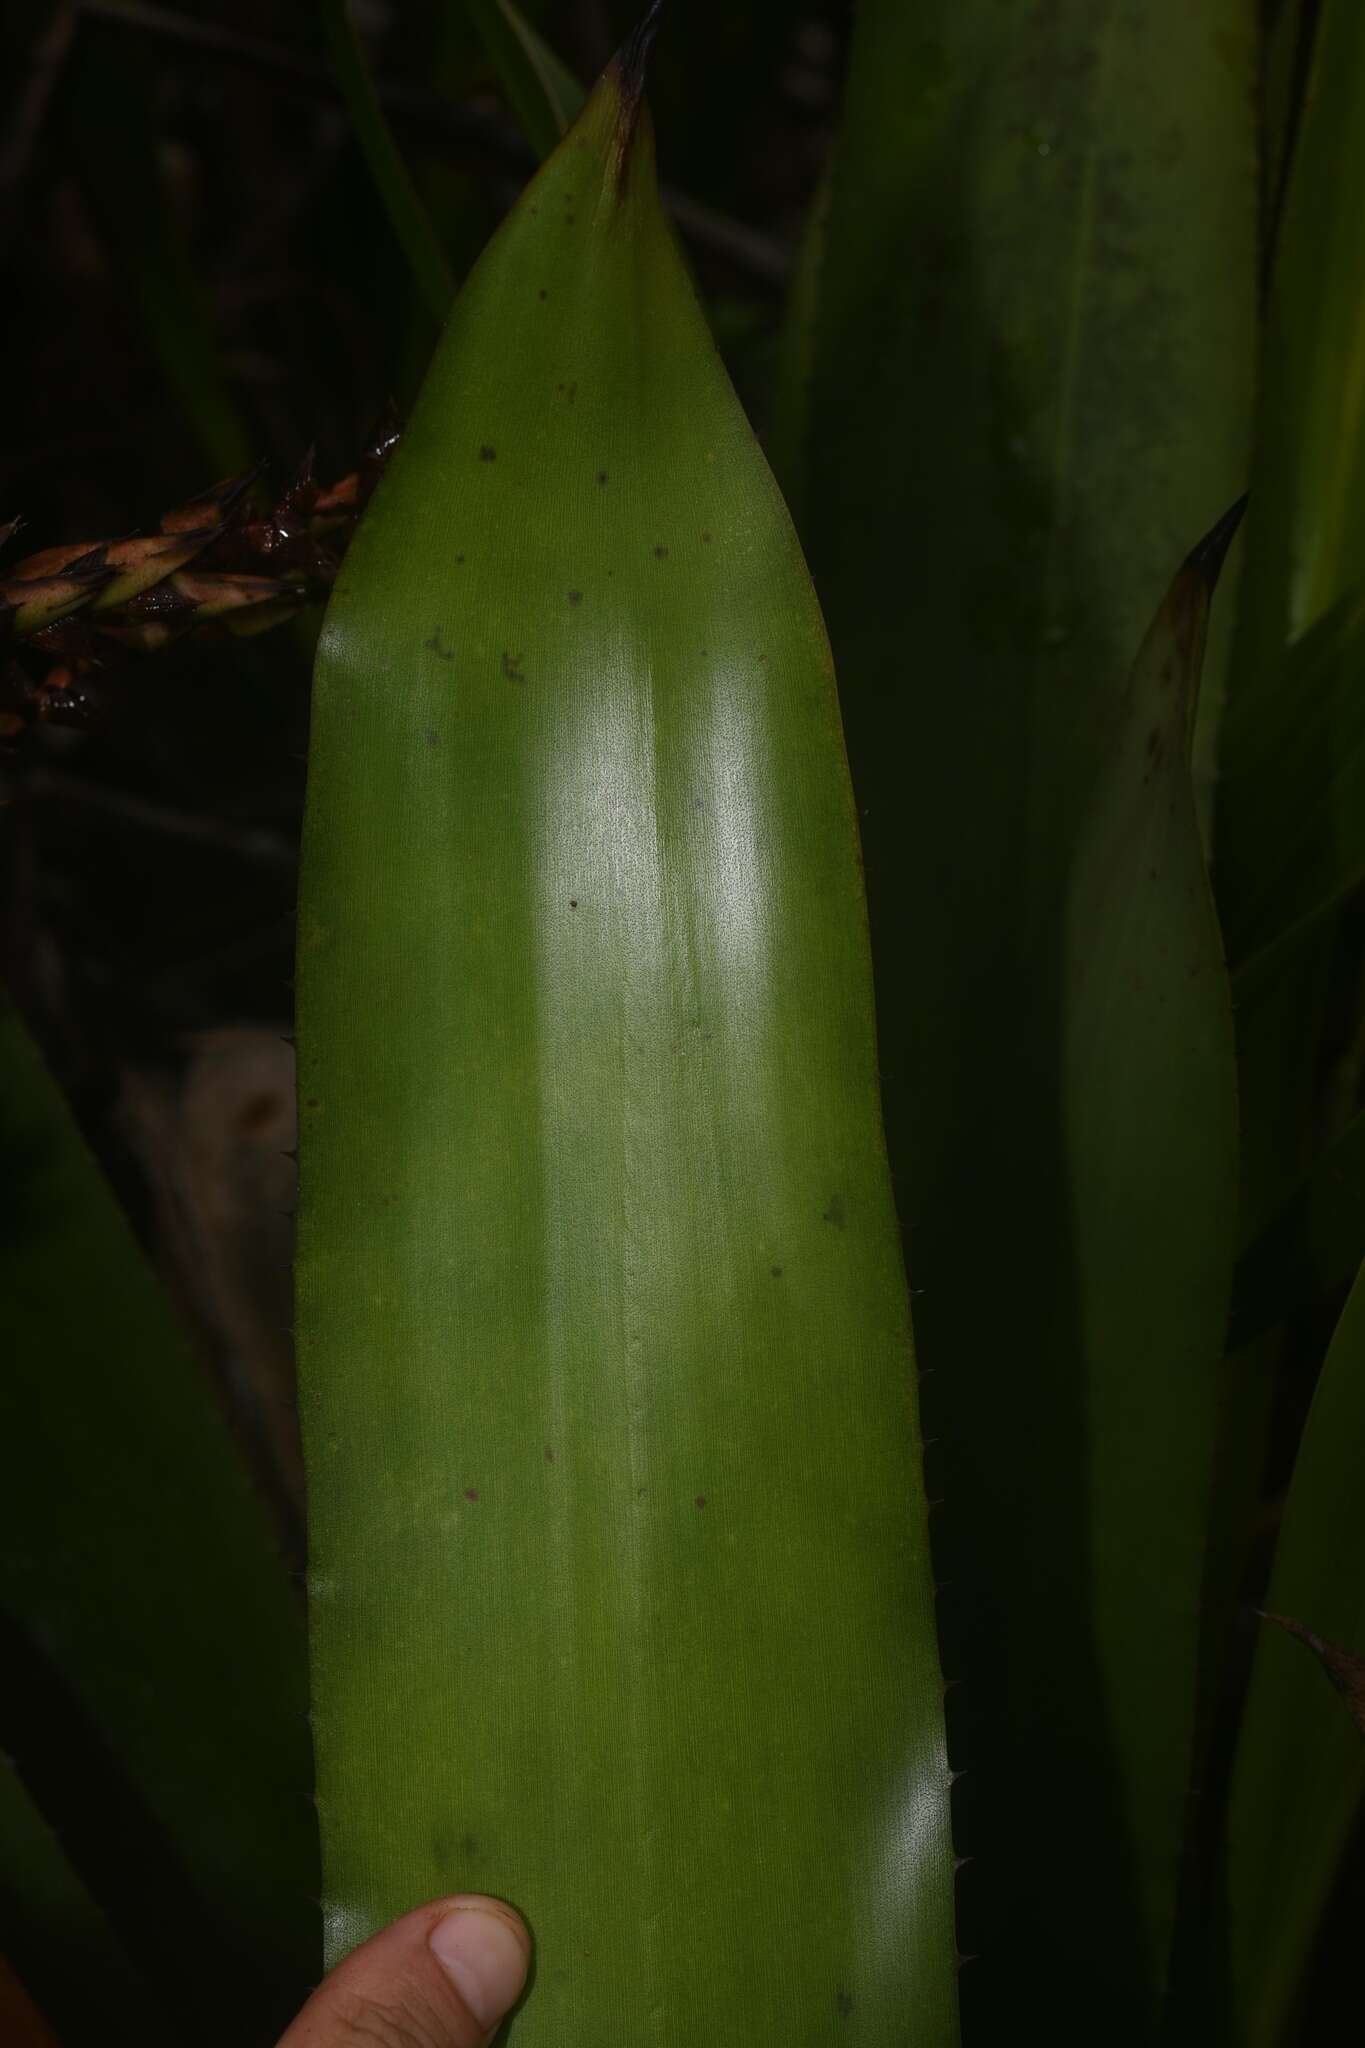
[278,1894,530,2048]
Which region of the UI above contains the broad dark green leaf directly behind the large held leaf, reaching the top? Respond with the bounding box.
[789,0,1257,2042]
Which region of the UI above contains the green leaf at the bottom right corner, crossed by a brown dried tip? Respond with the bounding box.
[1226,1278,1365,2048]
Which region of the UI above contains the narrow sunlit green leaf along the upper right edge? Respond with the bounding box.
[1218,0,1365,956]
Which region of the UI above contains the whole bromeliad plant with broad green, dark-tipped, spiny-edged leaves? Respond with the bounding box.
[2,0,1365,2048]
